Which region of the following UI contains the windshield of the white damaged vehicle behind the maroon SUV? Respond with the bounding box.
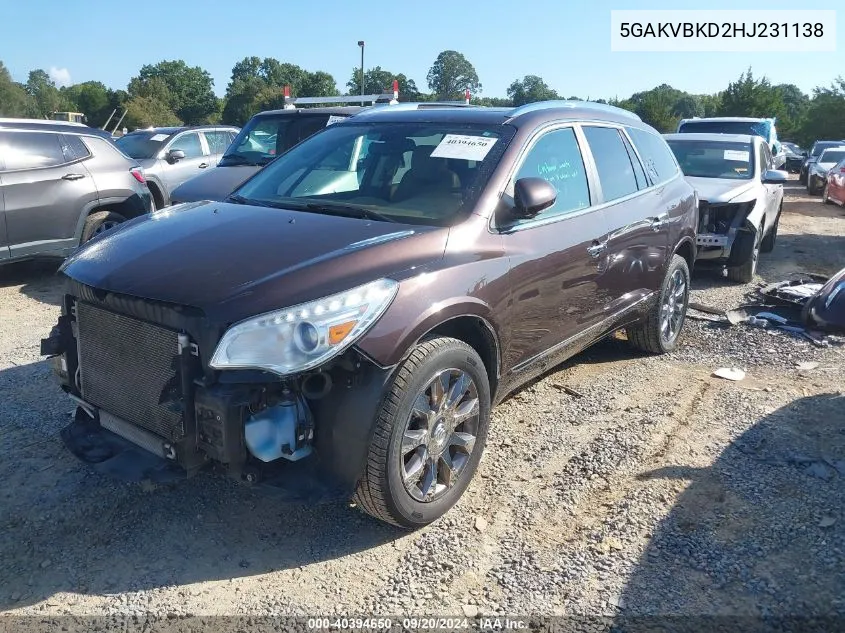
[668,140,754,180]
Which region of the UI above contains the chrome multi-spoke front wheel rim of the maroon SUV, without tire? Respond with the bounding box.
[400,369,480,502]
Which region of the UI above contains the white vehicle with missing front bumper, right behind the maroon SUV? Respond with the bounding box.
[664,133,788,283]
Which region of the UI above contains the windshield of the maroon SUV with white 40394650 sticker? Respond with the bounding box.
[235,123,514,226]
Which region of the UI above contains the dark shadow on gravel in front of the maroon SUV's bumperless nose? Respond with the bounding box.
[0,362,404,611]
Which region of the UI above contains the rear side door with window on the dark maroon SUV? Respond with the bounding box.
[581,124,669,317]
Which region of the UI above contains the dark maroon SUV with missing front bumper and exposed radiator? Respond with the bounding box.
[42,102,697,528]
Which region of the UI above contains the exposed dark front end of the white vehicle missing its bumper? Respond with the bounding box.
[696,199,756,266]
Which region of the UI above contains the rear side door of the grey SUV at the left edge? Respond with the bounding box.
[0,131,97,258]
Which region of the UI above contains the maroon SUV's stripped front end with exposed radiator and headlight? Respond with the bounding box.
[41,281,402,491]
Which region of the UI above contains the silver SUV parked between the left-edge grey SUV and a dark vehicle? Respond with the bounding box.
[115,125,239,209]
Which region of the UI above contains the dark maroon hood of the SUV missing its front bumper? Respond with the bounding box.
[61,202,449,323]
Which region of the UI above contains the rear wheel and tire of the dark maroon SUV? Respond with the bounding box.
[626,255,690,354]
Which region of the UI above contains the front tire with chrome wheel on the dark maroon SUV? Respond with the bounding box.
[353,337,491,529]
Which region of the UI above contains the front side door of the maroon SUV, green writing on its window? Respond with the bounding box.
[497,125,607,374]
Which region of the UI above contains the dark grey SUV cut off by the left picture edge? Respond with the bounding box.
[0,119,152,263]
